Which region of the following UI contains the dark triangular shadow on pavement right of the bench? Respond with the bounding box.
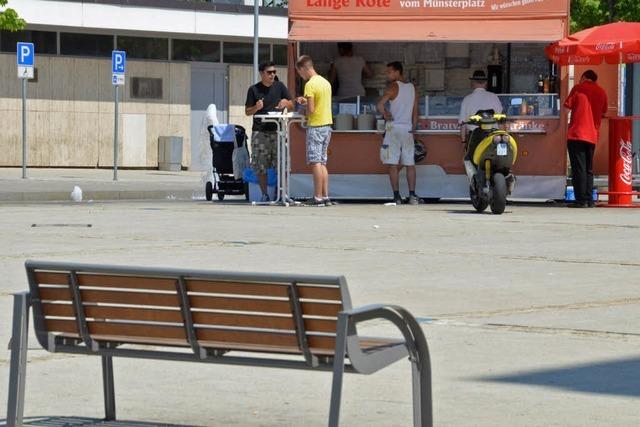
[480,358,640,397]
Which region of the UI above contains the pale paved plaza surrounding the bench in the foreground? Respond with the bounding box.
[0,200,640,426]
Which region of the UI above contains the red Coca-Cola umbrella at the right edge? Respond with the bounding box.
[545,22,640,65]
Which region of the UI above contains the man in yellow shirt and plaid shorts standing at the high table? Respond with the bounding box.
[296,55,333,206]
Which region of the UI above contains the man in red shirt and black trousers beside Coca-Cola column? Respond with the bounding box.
[564,70,608,208]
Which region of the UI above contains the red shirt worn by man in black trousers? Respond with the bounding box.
[564,80,608,144]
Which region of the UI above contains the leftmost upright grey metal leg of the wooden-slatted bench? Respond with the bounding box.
[7,292,29,427]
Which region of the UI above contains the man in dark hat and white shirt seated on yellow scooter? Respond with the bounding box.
[459,70,502,167]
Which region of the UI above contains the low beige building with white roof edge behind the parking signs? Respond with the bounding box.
[0,0,287,170]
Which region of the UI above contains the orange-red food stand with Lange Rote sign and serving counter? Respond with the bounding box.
[288,0,569,199]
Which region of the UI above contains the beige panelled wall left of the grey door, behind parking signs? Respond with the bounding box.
[0,54,191,167]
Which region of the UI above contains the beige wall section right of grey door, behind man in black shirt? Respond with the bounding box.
[229,65,288,137]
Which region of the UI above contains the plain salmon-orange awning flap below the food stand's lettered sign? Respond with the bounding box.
[289,19,565,42]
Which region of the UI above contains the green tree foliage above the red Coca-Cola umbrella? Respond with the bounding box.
[571,0,640,33]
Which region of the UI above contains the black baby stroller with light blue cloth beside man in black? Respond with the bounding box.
[205,125,249,201]
